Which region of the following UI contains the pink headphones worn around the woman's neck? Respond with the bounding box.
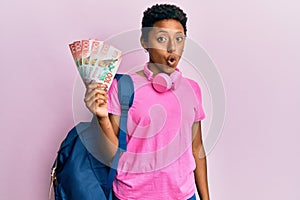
[144,63,182,93]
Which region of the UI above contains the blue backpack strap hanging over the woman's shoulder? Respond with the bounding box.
[107,74,134,188]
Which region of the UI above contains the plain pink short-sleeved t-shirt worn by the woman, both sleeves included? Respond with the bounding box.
[108,73,205,200]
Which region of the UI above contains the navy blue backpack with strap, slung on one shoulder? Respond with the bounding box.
[49,74,134,200]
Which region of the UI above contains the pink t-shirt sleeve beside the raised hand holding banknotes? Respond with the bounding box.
[107,79,121,116]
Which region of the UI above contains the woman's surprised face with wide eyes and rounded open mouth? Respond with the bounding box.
[141,19,185,74]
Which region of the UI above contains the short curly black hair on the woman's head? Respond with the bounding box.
[142,4,187,39]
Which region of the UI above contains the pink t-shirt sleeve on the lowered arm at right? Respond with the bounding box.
[189,79,205,122]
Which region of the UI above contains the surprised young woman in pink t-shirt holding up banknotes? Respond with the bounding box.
[85,4,209,200]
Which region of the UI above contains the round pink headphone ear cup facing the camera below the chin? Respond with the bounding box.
[152,73,172,93]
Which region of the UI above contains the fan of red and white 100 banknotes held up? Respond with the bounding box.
[69,39,122,90]
